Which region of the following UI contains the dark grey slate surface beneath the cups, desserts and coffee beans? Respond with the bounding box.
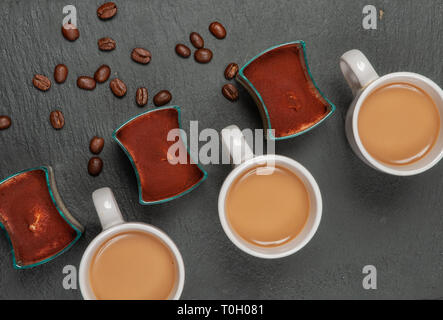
[0,0,443,299]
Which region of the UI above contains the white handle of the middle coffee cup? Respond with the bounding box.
[221,125,254,166]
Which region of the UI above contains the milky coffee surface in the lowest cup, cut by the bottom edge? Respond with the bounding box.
[89,231,177,300]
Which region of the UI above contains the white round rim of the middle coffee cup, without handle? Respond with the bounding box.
[218,154,322,259]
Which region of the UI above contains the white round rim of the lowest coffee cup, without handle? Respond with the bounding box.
[79,222,185,300]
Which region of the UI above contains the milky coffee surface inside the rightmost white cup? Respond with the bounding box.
[358,83,440,166]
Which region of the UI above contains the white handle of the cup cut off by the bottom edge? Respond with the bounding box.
[92,188,125,230]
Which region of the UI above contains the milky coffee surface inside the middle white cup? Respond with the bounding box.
[225,166,310,247]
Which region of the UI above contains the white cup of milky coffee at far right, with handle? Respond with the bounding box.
[340,49,443,176]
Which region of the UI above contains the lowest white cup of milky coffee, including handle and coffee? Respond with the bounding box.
[79,188,185,300]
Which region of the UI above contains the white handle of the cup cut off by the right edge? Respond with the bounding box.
[340,49,379,96]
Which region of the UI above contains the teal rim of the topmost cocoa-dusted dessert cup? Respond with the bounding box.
[238,40,336,140]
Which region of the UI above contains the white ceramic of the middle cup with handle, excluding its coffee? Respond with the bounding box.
[218,125,322,259]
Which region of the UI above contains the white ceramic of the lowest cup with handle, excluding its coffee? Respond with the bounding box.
[79,188,185,300]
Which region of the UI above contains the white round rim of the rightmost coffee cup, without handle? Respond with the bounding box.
[352,72,443,176]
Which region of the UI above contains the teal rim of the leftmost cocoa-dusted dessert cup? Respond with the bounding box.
[0,166,82,270]
